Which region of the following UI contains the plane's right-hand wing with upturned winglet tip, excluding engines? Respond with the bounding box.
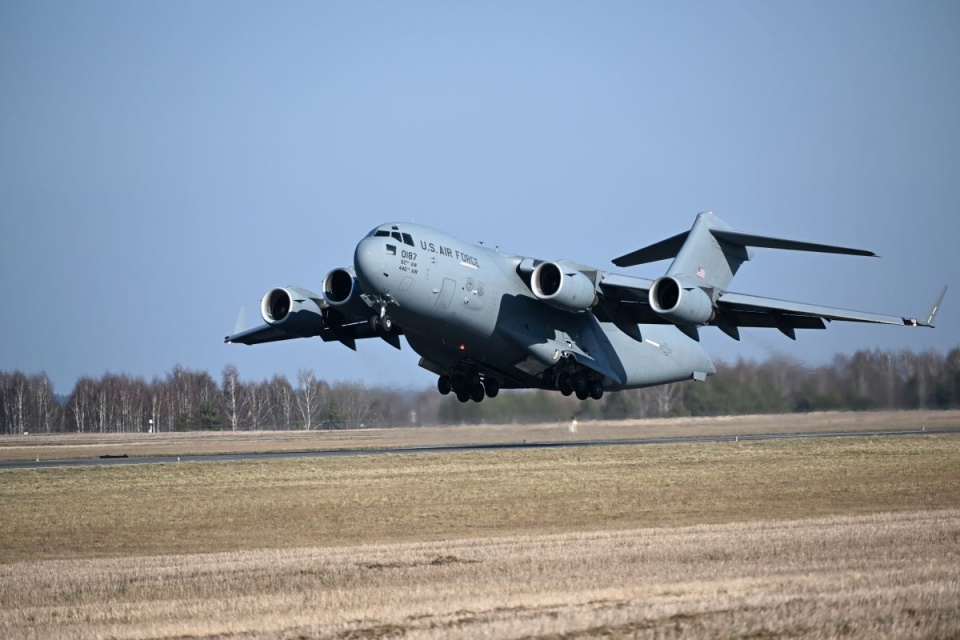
[600,274,947,339]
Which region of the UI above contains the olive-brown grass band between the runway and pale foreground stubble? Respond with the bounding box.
[0,436,960,562]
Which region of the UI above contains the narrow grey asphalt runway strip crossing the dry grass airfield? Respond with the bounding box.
[0,427,960,471]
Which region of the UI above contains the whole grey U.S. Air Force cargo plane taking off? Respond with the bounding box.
[225,212,946,402]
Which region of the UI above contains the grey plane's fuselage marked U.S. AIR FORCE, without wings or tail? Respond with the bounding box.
[354,223,715,390]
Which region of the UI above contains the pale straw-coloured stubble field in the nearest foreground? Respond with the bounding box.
[0,509,960,638]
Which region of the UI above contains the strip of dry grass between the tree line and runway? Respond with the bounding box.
[0,411,960,461]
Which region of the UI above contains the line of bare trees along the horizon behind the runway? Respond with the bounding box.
[0,348,960,434]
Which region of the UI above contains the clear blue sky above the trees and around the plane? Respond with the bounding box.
[0,0,960,393]
